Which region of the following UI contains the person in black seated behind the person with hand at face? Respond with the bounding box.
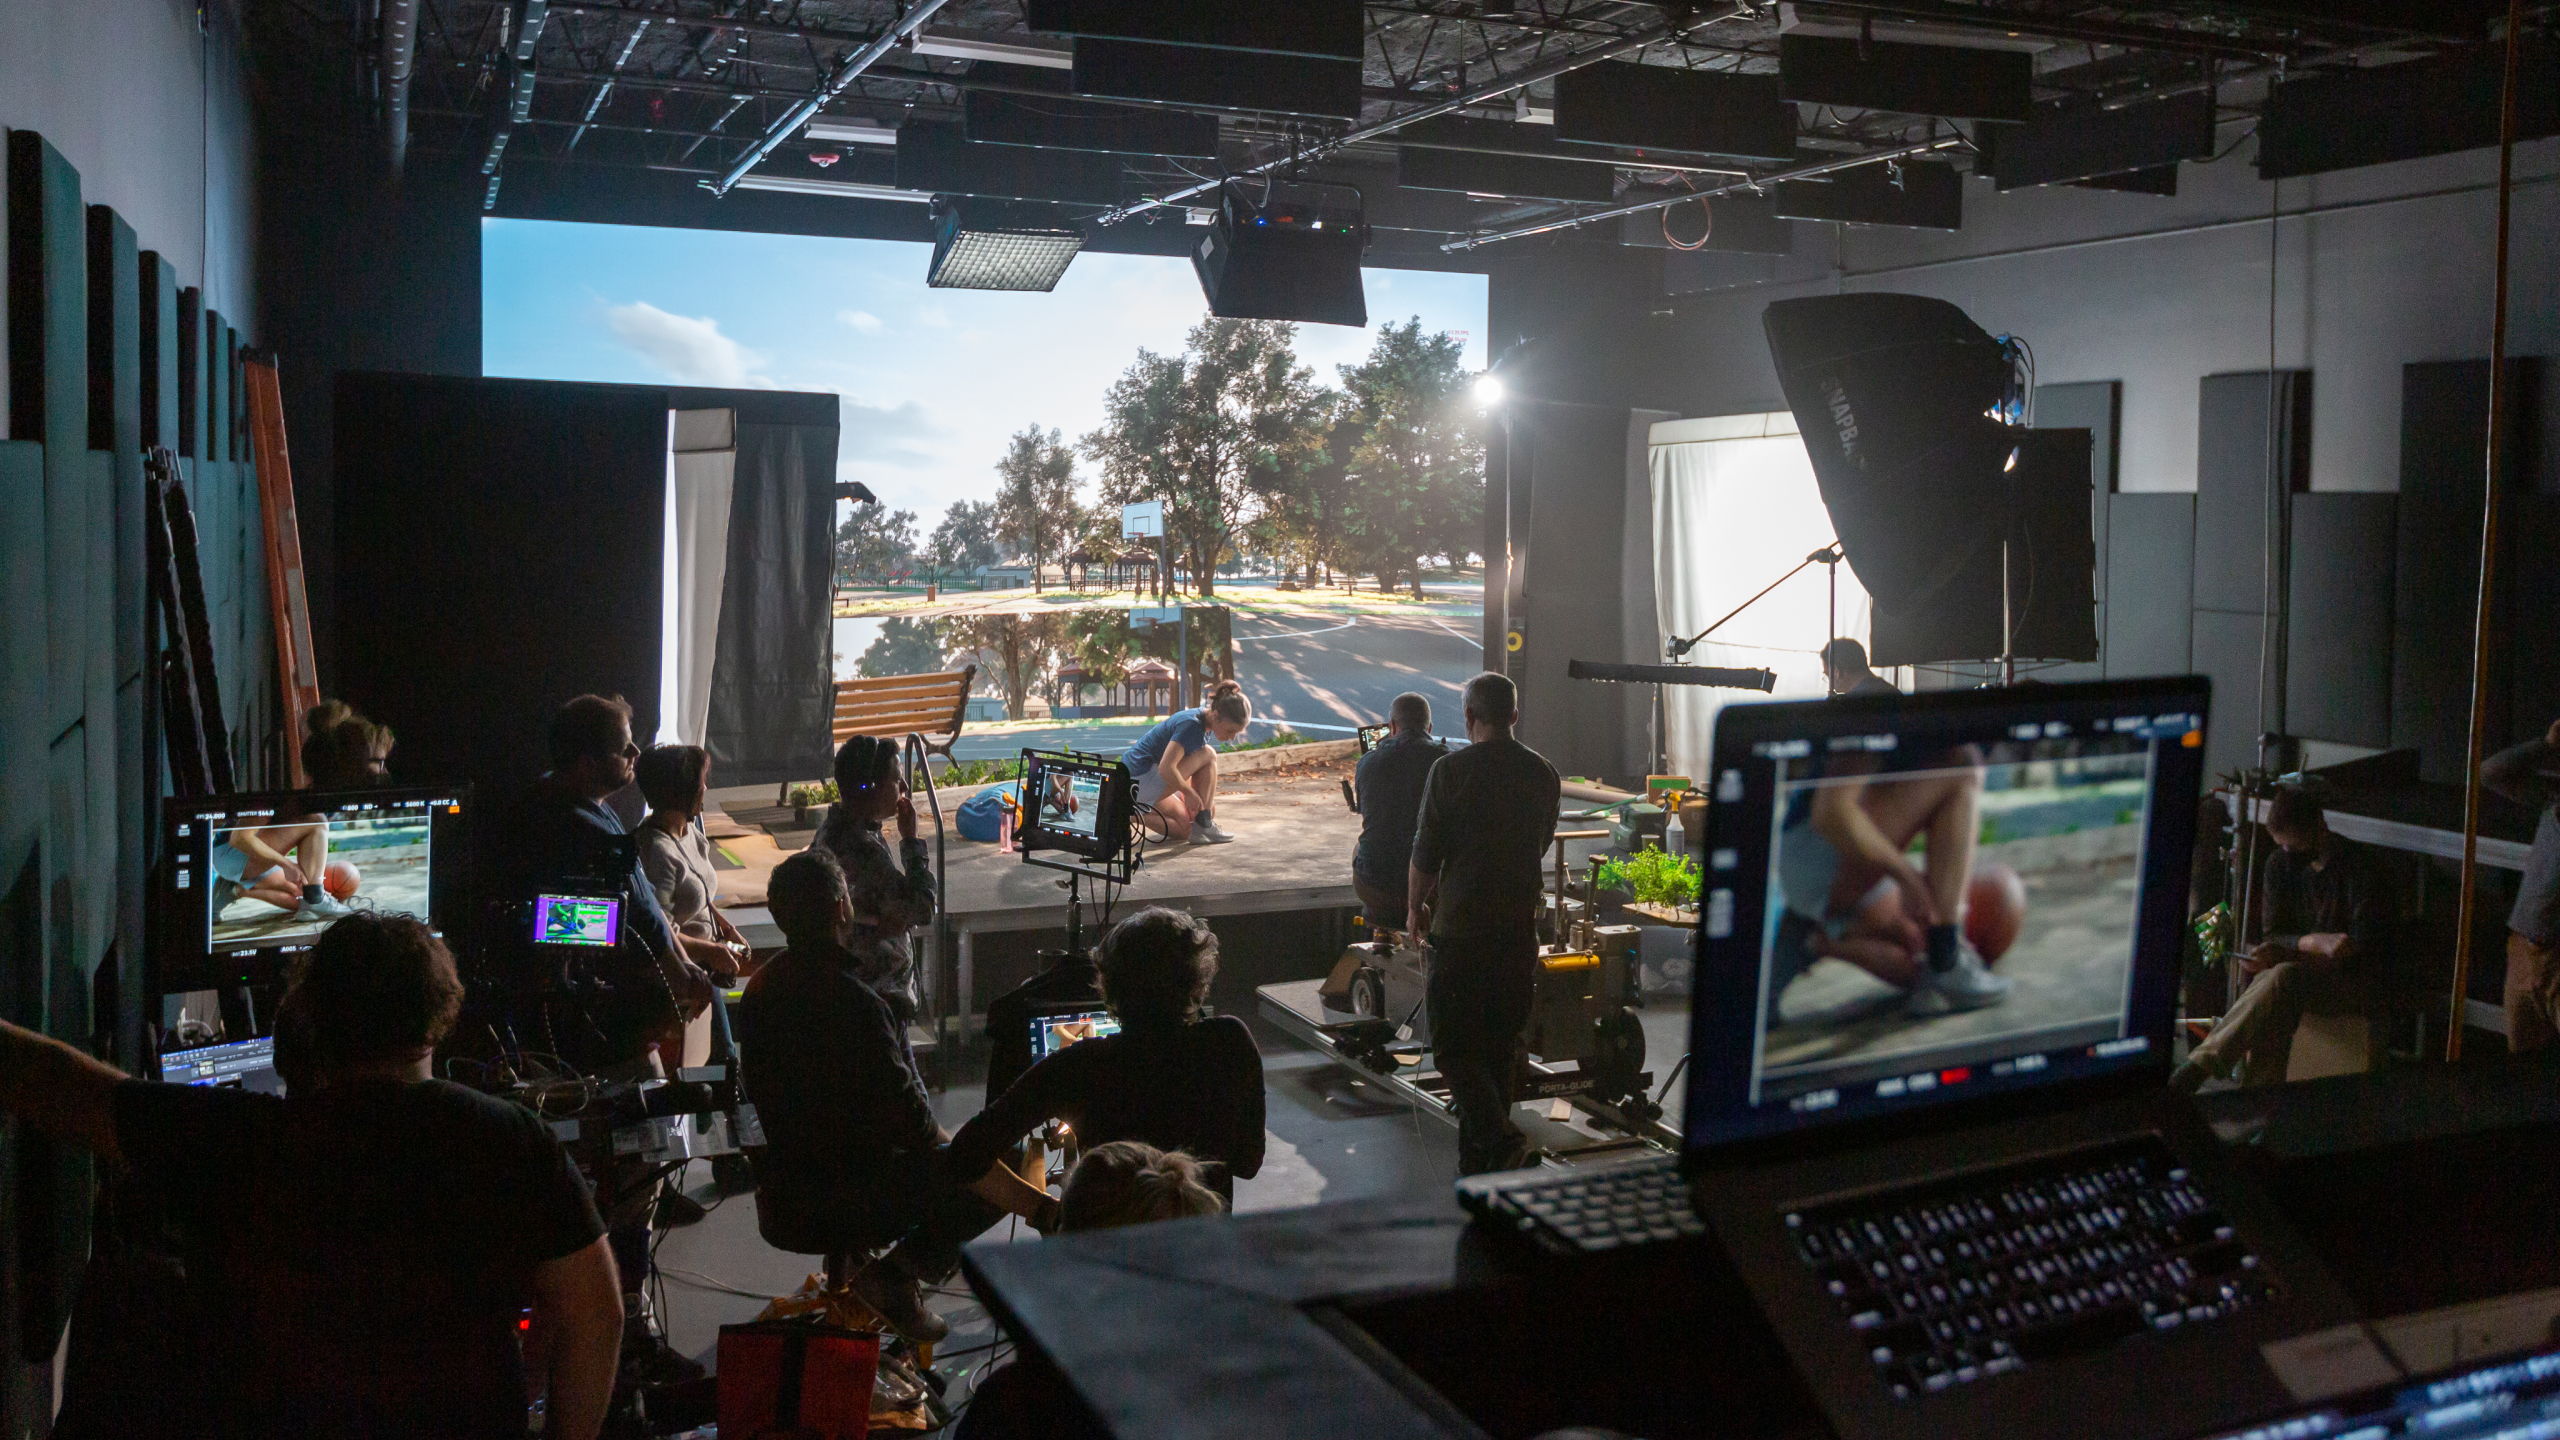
[737,846,1057,1345]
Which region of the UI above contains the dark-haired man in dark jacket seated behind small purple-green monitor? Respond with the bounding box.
[481,694,717,1381]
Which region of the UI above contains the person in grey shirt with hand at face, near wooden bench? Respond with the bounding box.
[814,735,934,1025]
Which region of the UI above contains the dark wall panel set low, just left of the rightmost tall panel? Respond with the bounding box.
[2284,492,2399,751]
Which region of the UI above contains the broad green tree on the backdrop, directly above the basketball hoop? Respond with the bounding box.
[1083,320,1326,597]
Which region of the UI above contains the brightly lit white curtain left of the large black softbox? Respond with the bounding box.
[1649,410,1866,776]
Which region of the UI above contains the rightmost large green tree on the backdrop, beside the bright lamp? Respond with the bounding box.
[1341,315,1485,600]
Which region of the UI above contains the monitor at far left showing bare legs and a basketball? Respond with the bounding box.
[151,784,471,994]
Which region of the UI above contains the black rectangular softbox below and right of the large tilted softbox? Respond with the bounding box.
[1869,430,2097,666]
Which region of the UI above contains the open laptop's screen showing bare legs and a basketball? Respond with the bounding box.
[1684,676,2207,1156]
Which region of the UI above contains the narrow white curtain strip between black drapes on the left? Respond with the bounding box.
[658,410,737,746]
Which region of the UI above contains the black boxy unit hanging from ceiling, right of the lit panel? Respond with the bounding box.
[1190,182,1370,325]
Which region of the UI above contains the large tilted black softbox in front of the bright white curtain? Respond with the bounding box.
[1761,295,2012,612]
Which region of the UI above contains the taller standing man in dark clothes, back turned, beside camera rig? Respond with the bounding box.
[1405,671,1564,1176]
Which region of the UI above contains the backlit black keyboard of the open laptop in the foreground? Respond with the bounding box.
[1784,1138,2268,1399]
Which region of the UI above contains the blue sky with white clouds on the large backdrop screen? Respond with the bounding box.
[481,220,1485,533]
